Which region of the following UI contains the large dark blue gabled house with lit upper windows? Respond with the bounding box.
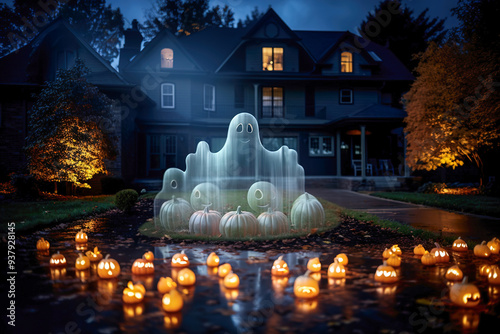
[0,9,414,190]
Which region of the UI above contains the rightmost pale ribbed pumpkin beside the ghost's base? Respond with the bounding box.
[290,193,325,231]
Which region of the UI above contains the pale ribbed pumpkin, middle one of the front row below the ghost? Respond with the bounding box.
[219,206,259,238]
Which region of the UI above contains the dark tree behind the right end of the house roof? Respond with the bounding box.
[358,0,447,71]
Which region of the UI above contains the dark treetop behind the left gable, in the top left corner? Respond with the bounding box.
[0,0,123,62]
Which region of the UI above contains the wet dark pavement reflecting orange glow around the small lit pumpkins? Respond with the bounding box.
[2,215,500,333]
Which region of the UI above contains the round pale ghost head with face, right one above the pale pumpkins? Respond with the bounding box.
[247,181,282,212]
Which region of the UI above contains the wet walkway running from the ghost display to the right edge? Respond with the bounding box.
[307,188,500,242]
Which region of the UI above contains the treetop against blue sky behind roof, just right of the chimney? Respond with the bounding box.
[141,0,234,41]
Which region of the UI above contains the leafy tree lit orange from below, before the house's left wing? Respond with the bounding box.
[26,59,116,189]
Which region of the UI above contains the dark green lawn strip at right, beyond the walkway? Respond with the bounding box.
[371,192,500,217]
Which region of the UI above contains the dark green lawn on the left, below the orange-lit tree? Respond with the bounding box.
[0,196,115,232]
